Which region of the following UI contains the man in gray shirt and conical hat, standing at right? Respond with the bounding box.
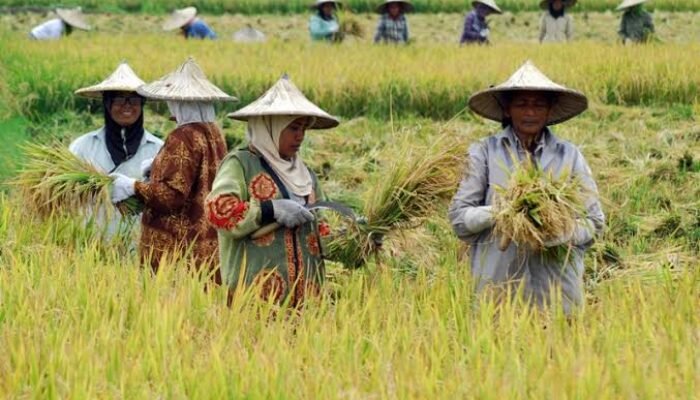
[449,61,605,314]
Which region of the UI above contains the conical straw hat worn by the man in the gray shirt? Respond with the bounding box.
[469,61,588,125]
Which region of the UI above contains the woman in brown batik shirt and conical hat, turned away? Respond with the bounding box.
[112,59,236,283]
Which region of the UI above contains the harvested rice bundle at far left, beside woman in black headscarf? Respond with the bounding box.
[11,143,141,215]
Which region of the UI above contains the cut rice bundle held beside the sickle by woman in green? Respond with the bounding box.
[325,136,462,268]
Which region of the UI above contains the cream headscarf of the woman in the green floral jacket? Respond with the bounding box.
[248,115,313,197]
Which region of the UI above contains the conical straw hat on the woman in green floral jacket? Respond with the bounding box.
[228,74,340,129]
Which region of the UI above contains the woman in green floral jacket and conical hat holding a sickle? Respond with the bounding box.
[207,76,338,306]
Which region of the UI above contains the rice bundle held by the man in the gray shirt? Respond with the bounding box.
[494,159,585,250]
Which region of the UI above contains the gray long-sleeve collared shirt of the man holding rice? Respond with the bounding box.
[448,127,605,313]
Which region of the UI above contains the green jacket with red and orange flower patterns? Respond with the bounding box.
[207,149,324,305]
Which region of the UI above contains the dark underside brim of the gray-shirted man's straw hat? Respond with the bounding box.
[469,87,588,125]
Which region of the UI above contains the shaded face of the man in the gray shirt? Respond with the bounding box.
[505,91,552,137]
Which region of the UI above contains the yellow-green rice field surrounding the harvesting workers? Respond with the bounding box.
[0,8,700,399]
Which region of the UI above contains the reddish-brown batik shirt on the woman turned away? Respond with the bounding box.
[136,123,226,282]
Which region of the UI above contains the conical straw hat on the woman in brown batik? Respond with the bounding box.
[137,57,238,101]
